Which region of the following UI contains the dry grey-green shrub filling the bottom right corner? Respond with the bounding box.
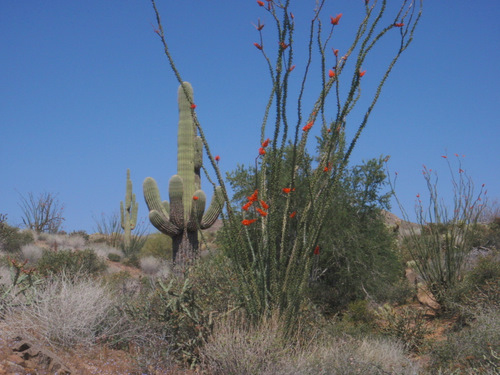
[432,309,500,374]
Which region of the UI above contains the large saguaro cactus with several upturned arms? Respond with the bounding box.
[143,82,224,272]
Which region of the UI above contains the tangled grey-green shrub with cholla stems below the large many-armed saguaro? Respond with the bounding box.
[124,251,236,364]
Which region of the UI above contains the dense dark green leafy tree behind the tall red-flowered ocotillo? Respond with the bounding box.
[226,152,401,313]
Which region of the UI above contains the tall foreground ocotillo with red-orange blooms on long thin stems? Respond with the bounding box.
[151,0,422,334]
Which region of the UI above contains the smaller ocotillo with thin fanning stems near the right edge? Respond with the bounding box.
[392,155,485,310]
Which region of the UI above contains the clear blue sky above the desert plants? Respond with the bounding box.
[0,0,500,232]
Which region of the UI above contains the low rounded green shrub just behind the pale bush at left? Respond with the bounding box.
[37,249,106,276]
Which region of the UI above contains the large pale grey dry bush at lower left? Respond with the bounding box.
[0,274,120,347]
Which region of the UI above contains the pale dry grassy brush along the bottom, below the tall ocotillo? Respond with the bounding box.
[201,318,419,375]
